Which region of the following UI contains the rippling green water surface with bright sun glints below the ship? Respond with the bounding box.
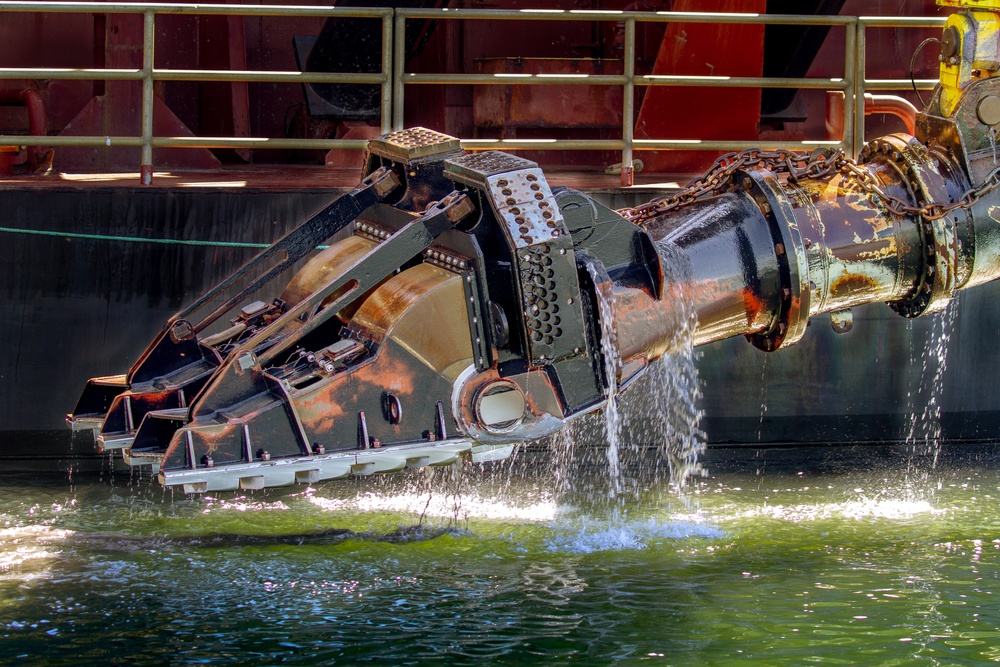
[0,449,1000,666]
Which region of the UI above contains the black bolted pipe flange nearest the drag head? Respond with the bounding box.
[734,169,810,352]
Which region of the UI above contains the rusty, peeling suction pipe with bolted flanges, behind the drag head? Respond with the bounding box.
[614,134,976,359]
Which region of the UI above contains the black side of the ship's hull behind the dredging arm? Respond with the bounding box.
[0,188,1000,470]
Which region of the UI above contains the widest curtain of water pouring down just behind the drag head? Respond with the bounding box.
[545,243,705,519]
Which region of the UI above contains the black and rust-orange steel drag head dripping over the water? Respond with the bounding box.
[69,128,662,492]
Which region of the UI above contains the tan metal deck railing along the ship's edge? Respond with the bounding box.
[0,0,945,185]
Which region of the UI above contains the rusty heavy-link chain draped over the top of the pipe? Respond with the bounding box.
[618,149,1000,225]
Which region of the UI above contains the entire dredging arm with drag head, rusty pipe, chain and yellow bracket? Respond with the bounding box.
[62,0,1000,492]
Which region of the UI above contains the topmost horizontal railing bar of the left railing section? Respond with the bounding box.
[0,0,393,18]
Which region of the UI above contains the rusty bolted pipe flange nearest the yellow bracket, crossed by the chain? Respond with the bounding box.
[858,134,968,318]
